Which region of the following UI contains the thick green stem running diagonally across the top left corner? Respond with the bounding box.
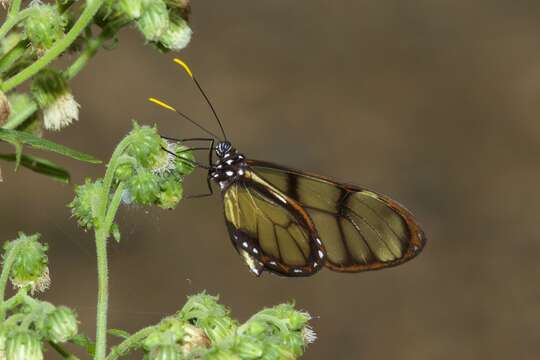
[0,0,105,92]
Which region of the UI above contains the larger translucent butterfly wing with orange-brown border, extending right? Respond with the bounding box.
[248,160,426,272]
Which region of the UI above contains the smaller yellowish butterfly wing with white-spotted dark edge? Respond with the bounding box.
[223,171,324,276]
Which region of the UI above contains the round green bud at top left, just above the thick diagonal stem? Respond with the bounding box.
[23,2,67,54]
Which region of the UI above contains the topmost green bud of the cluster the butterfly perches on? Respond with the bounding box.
[127,122,162,166]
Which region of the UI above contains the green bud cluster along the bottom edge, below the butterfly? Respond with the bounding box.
[141,294,315,360]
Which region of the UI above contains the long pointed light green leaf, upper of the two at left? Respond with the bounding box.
[0,129,101,164]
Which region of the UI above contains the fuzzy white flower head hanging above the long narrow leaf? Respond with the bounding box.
[43,92,80,131]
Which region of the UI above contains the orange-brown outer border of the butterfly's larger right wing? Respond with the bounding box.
[247,160,427,273]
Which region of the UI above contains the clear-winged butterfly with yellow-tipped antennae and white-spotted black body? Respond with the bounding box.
[149,59,427,277]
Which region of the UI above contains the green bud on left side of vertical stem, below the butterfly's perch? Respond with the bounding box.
[68,178,103,229]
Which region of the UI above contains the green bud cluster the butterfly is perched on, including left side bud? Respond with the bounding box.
[69,122,195,237]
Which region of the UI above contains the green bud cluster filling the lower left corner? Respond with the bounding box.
[0,233,78,360]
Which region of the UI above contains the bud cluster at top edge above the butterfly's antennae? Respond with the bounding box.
[100,0,192,51]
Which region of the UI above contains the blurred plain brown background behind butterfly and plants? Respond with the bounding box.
[0,0,540,360]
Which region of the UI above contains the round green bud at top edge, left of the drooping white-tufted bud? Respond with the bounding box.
[137,0,169,41]
